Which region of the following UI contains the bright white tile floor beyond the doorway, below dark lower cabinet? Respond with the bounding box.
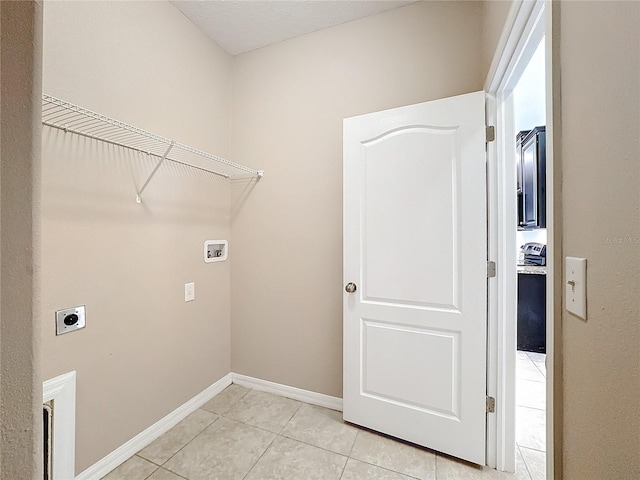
[516,351,546,480]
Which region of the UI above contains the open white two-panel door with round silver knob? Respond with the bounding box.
[344,92,487,464]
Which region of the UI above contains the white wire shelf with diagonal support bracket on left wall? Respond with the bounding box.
[42,94,264,203]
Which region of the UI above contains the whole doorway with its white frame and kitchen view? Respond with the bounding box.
[485,0,555,480]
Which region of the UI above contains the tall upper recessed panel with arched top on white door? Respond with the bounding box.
[362,127,459,308]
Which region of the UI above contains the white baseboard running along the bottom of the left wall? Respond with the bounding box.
[77,373,232,480]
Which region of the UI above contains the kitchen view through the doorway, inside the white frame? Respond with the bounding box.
[512,38,547,480]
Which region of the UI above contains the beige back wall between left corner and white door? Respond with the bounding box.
[231,2,484,396]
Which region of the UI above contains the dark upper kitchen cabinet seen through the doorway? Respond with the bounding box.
[516,127,547,230]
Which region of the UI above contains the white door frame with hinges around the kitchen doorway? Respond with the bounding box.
[485,0,556,480]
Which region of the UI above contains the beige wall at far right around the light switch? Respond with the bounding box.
[560,2,640,480]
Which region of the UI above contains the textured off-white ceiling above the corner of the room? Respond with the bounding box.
[171,0,415,55]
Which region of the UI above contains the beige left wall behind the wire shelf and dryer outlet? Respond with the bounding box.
[39,2,233,472]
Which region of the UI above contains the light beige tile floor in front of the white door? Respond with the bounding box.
[104,360,544,480]
